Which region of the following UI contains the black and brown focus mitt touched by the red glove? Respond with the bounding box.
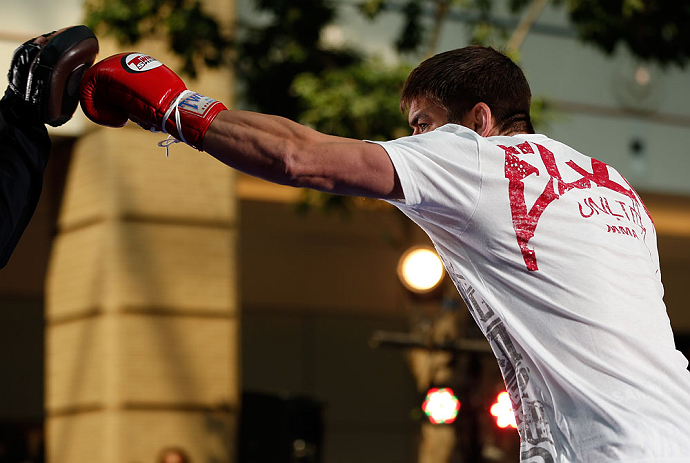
[8,26,98,127]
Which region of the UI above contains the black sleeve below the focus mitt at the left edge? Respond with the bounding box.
[0,88,50,268]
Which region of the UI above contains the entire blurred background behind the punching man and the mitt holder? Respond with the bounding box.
[0,0,690,463]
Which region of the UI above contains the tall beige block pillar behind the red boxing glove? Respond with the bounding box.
[40,1,240,463]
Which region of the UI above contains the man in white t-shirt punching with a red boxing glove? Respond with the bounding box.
[81,46,690,463]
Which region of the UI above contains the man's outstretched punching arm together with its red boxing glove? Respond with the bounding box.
[80,53,402,199]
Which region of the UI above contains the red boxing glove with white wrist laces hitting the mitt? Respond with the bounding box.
[79,53,227,150]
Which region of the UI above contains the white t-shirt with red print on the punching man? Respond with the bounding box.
[380,124,690,463]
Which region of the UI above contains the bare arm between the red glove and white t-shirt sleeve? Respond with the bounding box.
[203,110,403,199]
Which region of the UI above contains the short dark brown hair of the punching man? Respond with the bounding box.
[400,45,534,133]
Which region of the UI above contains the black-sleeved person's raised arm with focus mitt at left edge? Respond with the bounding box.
[0,26,98,268]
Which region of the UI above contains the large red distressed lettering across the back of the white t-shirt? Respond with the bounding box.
[498,142,651,271]
